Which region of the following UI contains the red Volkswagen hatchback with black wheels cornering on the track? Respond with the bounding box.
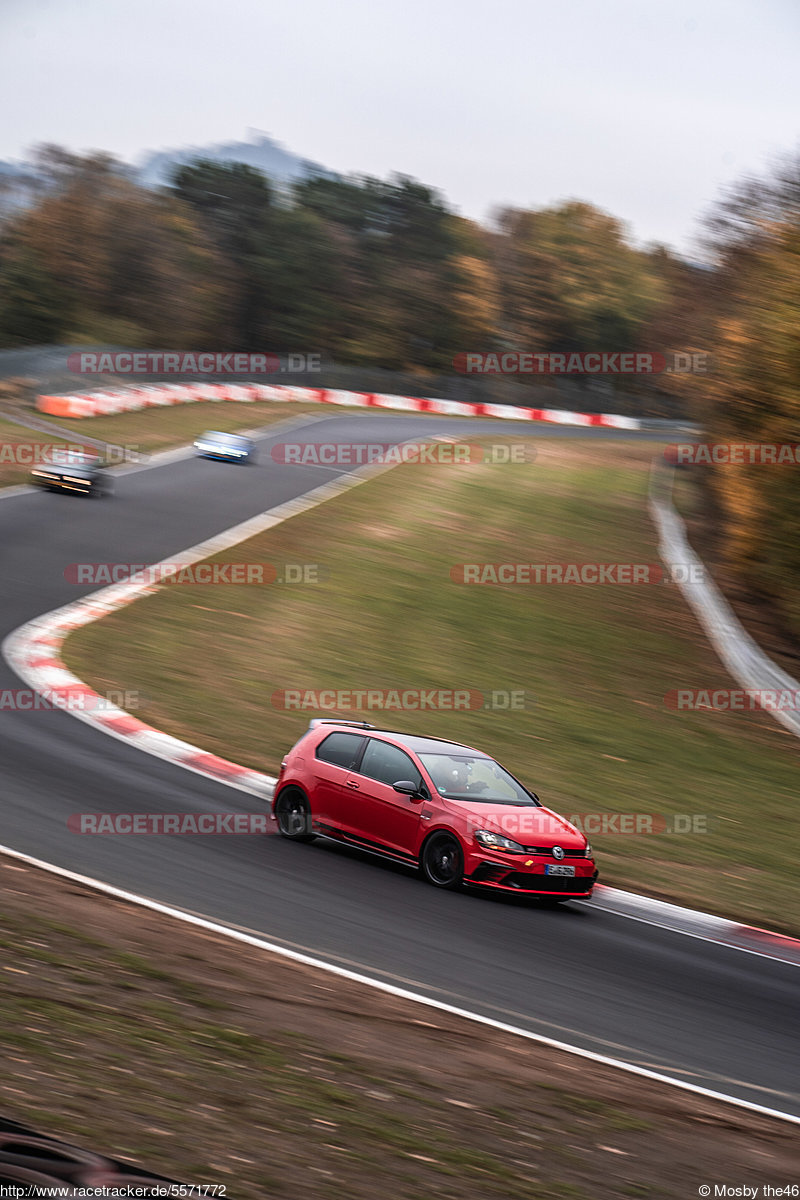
[272,720,597,901]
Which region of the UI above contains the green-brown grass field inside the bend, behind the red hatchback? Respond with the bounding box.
[66,439,800,932]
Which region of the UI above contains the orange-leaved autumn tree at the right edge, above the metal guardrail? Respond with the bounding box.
[696,157,800,635]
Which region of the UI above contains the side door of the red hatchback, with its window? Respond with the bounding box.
[344,738,431,856]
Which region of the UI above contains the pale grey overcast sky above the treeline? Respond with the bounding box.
[0,0,800,251]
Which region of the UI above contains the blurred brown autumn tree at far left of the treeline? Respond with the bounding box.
[0,148,225,347]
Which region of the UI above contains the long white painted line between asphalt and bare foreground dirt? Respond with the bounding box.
[0,846,800,1124]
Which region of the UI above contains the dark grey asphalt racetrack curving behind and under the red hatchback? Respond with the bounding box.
[0,414,800,1116]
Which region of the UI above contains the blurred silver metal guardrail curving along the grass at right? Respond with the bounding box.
[648,462,800,737]
